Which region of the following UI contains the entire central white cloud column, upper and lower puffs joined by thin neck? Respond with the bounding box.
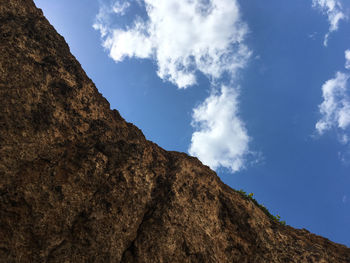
[94,0,251,171]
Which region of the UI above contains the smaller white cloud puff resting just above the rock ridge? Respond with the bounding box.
[189,86,250,172]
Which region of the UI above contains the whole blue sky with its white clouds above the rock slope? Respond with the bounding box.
[35,0,350,246]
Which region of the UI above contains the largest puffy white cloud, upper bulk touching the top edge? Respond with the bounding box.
[94,0,250,88]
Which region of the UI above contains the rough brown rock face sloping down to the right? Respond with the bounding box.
[0,0,350,263]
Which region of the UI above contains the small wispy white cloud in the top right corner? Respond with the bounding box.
[312,0,347,46]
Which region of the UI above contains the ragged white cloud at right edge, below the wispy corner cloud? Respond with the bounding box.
[316,72,350,135]
